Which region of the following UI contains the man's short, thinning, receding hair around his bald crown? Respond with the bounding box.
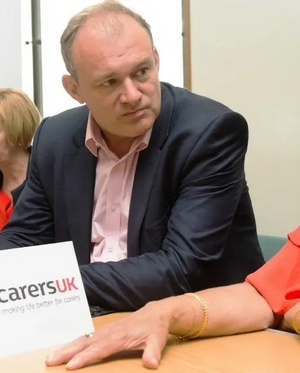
[60,0,153,77]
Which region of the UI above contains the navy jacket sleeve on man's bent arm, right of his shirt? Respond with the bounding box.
[81,112,248,311]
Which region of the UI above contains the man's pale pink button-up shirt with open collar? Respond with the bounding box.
[85,114,151,262]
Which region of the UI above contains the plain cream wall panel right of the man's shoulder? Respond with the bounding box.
[191,0,300,235]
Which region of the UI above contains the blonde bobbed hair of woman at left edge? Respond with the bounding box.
[0,88,41,151]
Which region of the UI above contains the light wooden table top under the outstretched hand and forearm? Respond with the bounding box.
[0,314,300,373]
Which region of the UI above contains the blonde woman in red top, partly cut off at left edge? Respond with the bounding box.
[0,88,40,230]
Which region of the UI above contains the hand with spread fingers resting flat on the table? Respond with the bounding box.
[46,302,172,370]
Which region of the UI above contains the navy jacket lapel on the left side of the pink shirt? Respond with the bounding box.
[64,123,97,264]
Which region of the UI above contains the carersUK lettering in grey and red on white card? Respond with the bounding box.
[0,277,78,303]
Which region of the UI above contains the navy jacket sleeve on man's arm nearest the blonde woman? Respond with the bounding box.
[0,120,54,246]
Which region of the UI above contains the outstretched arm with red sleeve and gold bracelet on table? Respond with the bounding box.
[46,227,300,370]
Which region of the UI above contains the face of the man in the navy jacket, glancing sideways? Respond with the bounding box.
[64,16,161,138]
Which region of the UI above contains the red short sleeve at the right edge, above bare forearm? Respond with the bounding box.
[246,227,300,314]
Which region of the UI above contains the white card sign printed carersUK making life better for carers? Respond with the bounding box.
[0,242,94,358]
